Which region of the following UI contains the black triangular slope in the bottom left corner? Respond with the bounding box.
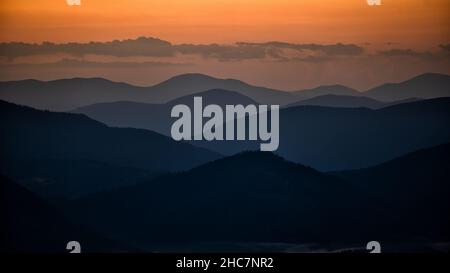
[0,176,132,253]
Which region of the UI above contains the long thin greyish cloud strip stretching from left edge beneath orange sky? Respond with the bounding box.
[0,37,364,61]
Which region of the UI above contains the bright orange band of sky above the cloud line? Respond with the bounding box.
[0,0,450,48]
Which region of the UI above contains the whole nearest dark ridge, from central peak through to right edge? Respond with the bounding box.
[66,144,450,251]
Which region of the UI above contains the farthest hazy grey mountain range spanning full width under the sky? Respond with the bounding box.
[0,73,450,111]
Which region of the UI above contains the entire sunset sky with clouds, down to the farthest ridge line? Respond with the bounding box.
[0,0,450,90]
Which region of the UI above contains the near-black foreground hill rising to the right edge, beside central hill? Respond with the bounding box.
[336,144,450,241]
